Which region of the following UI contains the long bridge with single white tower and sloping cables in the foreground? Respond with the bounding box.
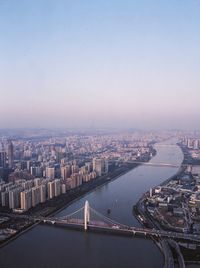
[1,201,200,243]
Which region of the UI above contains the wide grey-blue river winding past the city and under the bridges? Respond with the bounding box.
[0,140,188,268]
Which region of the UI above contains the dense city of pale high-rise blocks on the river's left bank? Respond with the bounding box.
[0,131,160,244]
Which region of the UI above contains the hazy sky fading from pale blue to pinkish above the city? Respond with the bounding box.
[0,0,200,129]
